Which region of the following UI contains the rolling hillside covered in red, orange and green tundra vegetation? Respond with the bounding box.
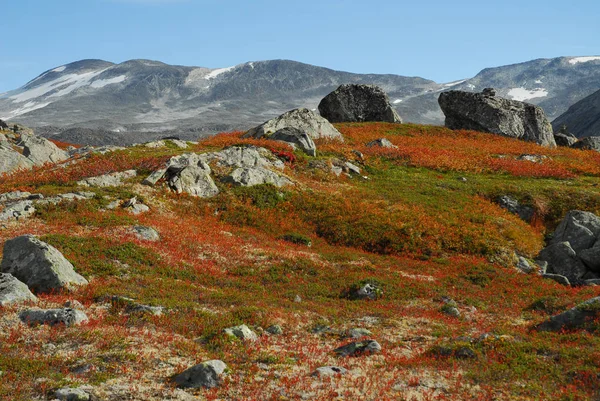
[0,123,600,400]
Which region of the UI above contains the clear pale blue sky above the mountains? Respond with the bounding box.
[0,0,600,93]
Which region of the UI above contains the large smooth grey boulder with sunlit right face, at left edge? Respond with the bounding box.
[0,235,88,293]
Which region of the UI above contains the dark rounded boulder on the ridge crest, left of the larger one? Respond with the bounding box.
[319,84,402,123]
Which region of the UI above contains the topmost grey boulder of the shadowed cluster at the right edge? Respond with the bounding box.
[549,210,600,252]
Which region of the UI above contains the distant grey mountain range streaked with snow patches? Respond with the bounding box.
[0,56,600,144]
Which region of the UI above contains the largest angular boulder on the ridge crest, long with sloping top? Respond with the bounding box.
[438,90,556,147]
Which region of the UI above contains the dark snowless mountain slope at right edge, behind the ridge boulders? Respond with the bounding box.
[552,87,600,138]
